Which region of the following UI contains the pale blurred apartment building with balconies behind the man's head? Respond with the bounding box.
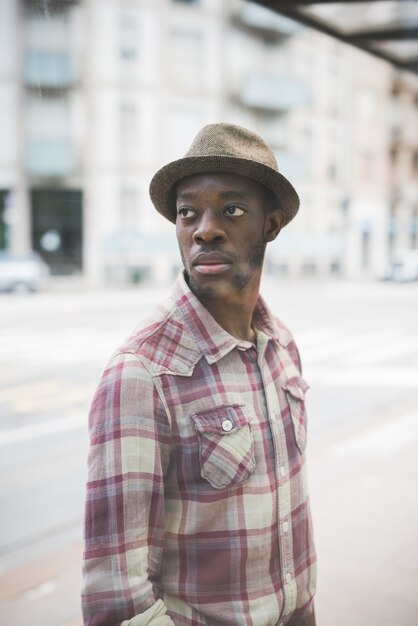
[0,0,418,285]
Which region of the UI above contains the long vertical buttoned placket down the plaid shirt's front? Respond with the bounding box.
[257,333,297,626]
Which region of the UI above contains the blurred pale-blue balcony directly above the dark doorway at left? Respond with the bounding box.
[26,139,76,177]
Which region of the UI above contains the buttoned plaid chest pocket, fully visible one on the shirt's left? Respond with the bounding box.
[192,405,256,489]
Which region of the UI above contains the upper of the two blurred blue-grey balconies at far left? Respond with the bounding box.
[24,50,75,89]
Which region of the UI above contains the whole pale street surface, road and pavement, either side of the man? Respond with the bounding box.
[0,277,418,626]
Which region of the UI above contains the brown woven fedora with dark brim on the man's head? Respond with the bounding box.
[150,123,299,226]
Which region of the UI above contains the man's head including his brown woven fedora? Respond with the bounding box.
[150,124,299,302]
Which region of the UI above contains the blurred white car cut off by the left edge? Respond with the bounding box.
[0,251,50,292]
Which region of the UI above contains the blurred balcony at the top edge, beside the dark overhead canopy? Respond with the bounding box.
[236,2,302,39]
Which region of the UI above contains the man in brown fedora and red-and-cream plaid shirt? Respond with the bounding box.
[83,124,315,626]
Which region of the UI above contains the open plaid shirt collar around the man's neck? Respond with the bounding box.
[172,273,287,363]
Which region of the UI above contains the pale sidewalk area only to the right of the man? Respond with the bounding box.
[309,411,418,626]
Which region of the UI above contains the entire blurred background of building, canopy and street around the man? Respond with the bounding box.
[0,0,418,626]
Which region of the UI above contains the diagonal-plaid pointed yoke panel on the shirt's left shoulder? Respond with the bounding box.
[116,298,201,376]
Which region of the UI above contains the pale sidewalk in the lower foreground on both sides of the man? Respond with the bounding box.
[0,413,418,626]
